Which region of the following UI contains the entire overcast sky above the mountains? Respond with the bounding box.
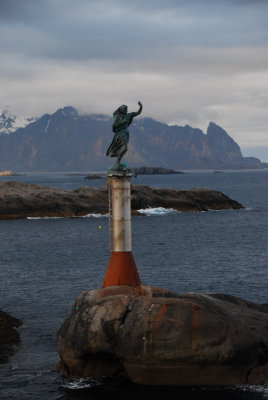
[0,0,268,161]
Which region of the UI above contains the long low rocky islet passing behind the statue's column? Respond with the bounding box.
[0,181,243,219]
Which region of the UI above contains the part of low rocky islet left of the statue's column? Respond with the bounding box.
[0,181,108,219]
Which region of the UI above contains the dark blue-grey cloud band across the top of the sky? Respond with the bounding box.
[1,0,268,60]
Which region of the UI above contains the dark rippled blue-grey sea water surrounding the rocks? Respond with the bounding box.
[0,170,268,400]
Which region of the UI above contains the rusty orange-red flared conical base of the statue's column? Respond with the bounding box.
[103,251,141,287]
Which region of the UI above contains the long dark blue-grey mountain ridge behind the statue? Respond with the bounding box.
[0,106,268,171]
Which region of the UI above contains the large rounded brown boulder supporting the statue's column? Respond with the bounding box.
[58,286,268,386]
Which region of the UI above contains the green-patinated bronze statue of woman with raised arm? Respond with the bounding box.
[106,101,142,170]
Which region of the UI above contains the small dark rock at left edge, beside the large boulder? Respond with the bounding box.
[0,310,21,363]
